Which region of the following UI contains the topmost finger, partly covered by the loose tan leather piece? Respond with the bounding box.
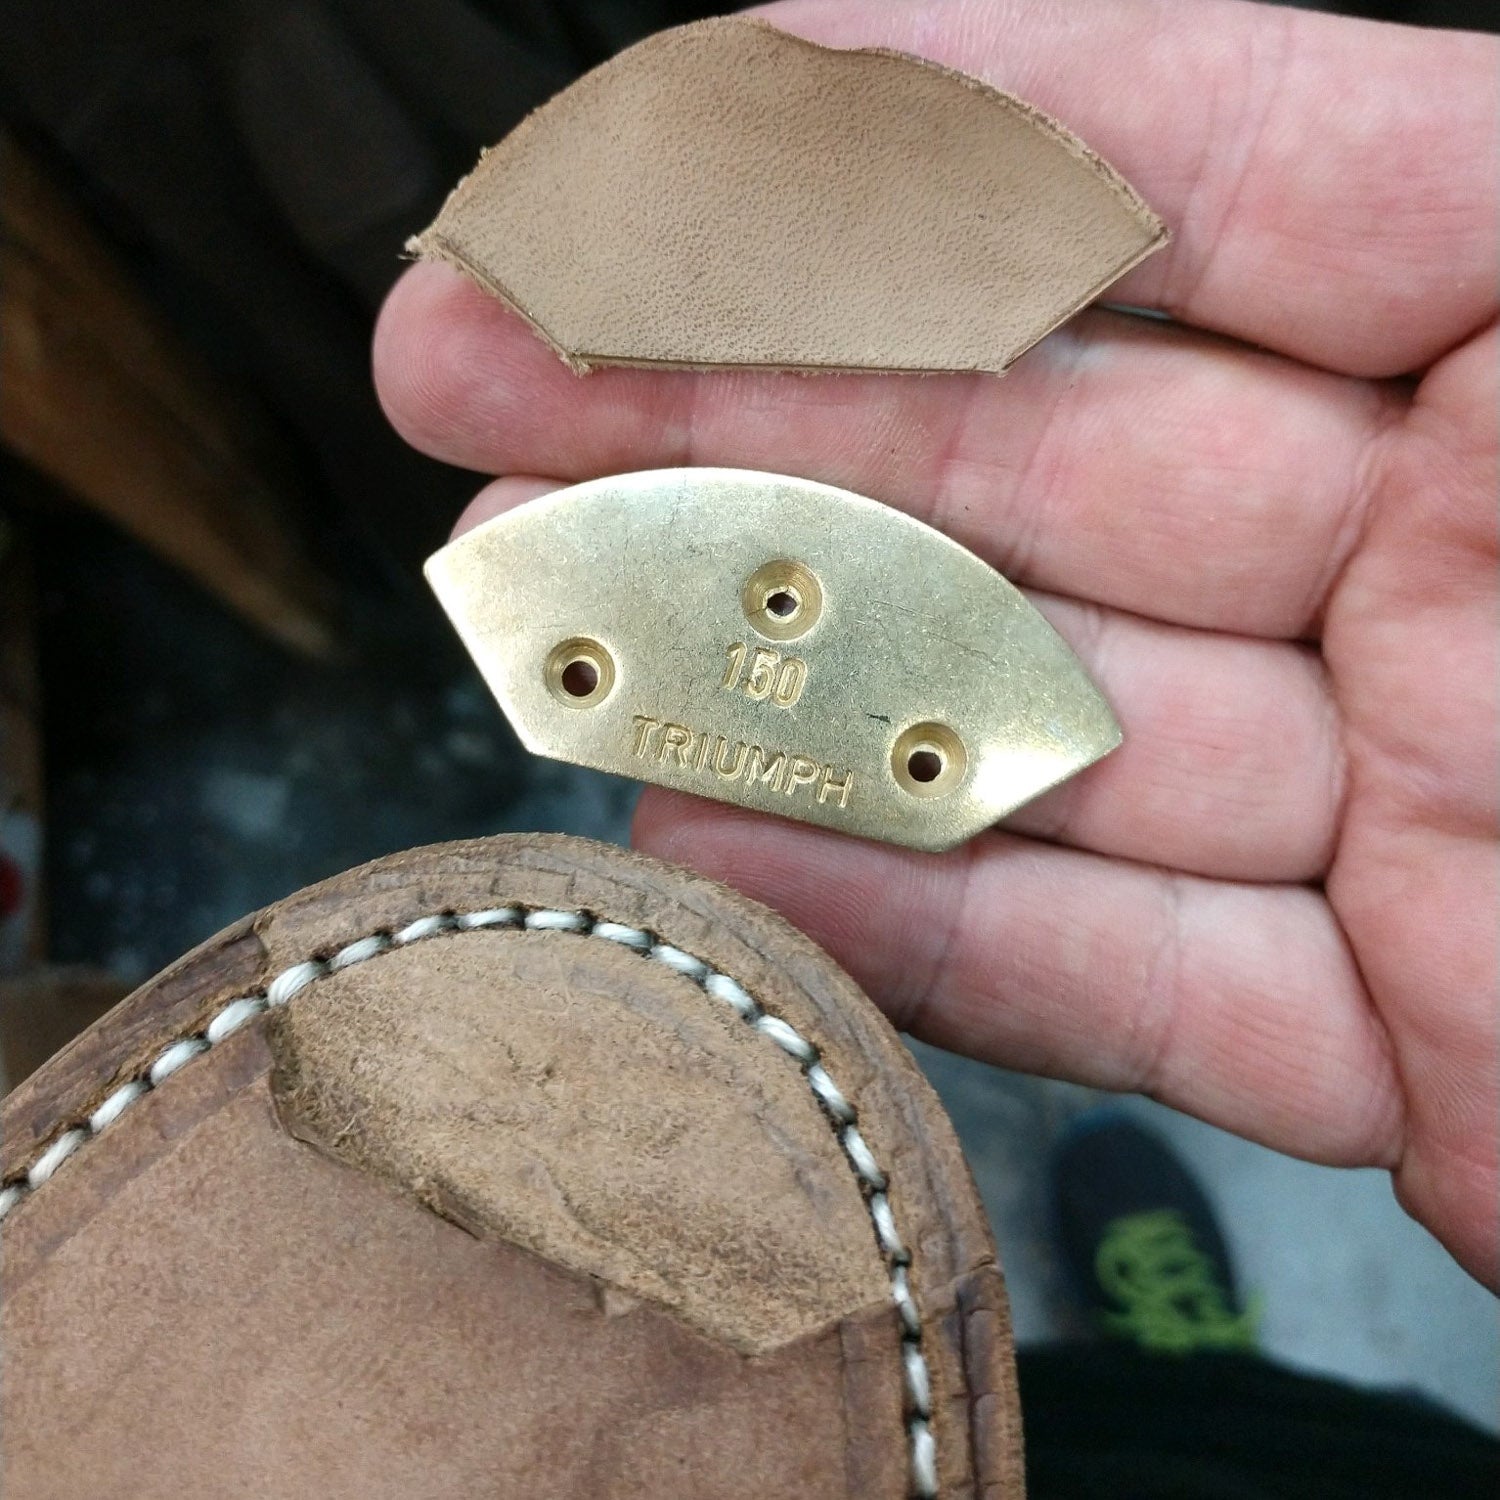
[761,0,1500,375]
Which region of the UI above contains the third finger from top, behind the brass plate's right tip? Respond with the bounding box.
[456,477,1344,881]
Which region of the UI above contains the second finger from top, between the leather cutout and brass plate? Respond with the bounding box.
[375,266,1404,636]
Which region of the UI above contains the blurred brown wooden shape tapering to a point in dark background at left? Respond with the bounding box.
[0,135,335,656]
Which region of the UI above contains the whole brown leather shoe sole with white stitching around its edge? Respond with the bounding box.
[0,836,1022,1500]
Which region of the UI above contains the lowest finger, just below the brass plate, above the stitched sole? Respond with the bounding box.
[636,791,1401,1167]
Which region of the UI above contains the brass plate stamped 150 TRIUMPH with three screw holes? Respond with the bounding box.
[426,468,1119,849]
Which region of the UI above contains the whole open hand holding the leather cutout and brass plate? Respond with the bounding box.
[377,0,1500,1280]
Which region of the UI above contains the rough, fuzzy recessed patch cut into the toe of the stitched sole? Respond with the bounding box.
[272,932,890,1355]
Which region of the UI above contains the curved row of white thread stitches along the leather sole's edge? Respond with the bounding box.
[0,906,938,1500]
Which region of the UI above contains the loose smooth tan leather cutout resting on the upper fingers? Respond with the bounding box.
[410,18,1167,371]
